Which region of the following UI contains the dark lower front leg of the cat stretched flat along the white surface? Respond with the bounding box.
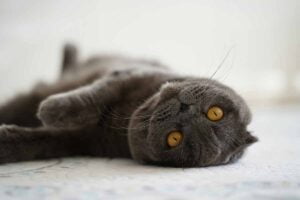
[0,125,131,163]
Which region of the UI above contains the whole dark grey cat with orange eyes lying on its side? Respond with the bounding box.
[0,44,257,167]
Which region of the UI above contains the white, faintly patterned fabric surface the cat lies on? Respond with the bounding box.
[0,106,300,200]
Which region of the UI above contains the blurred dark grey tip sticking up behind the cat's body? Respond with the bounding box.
[62,43,78,73]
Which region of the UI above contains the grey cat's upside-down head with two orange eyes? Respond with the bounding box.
[129,79,257,167]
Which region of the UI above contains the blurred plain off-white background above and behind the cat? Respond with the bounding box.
[0,0,300,108]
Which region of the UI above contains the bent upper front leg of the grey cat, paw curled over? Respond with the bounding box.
[37,76,122,128]
